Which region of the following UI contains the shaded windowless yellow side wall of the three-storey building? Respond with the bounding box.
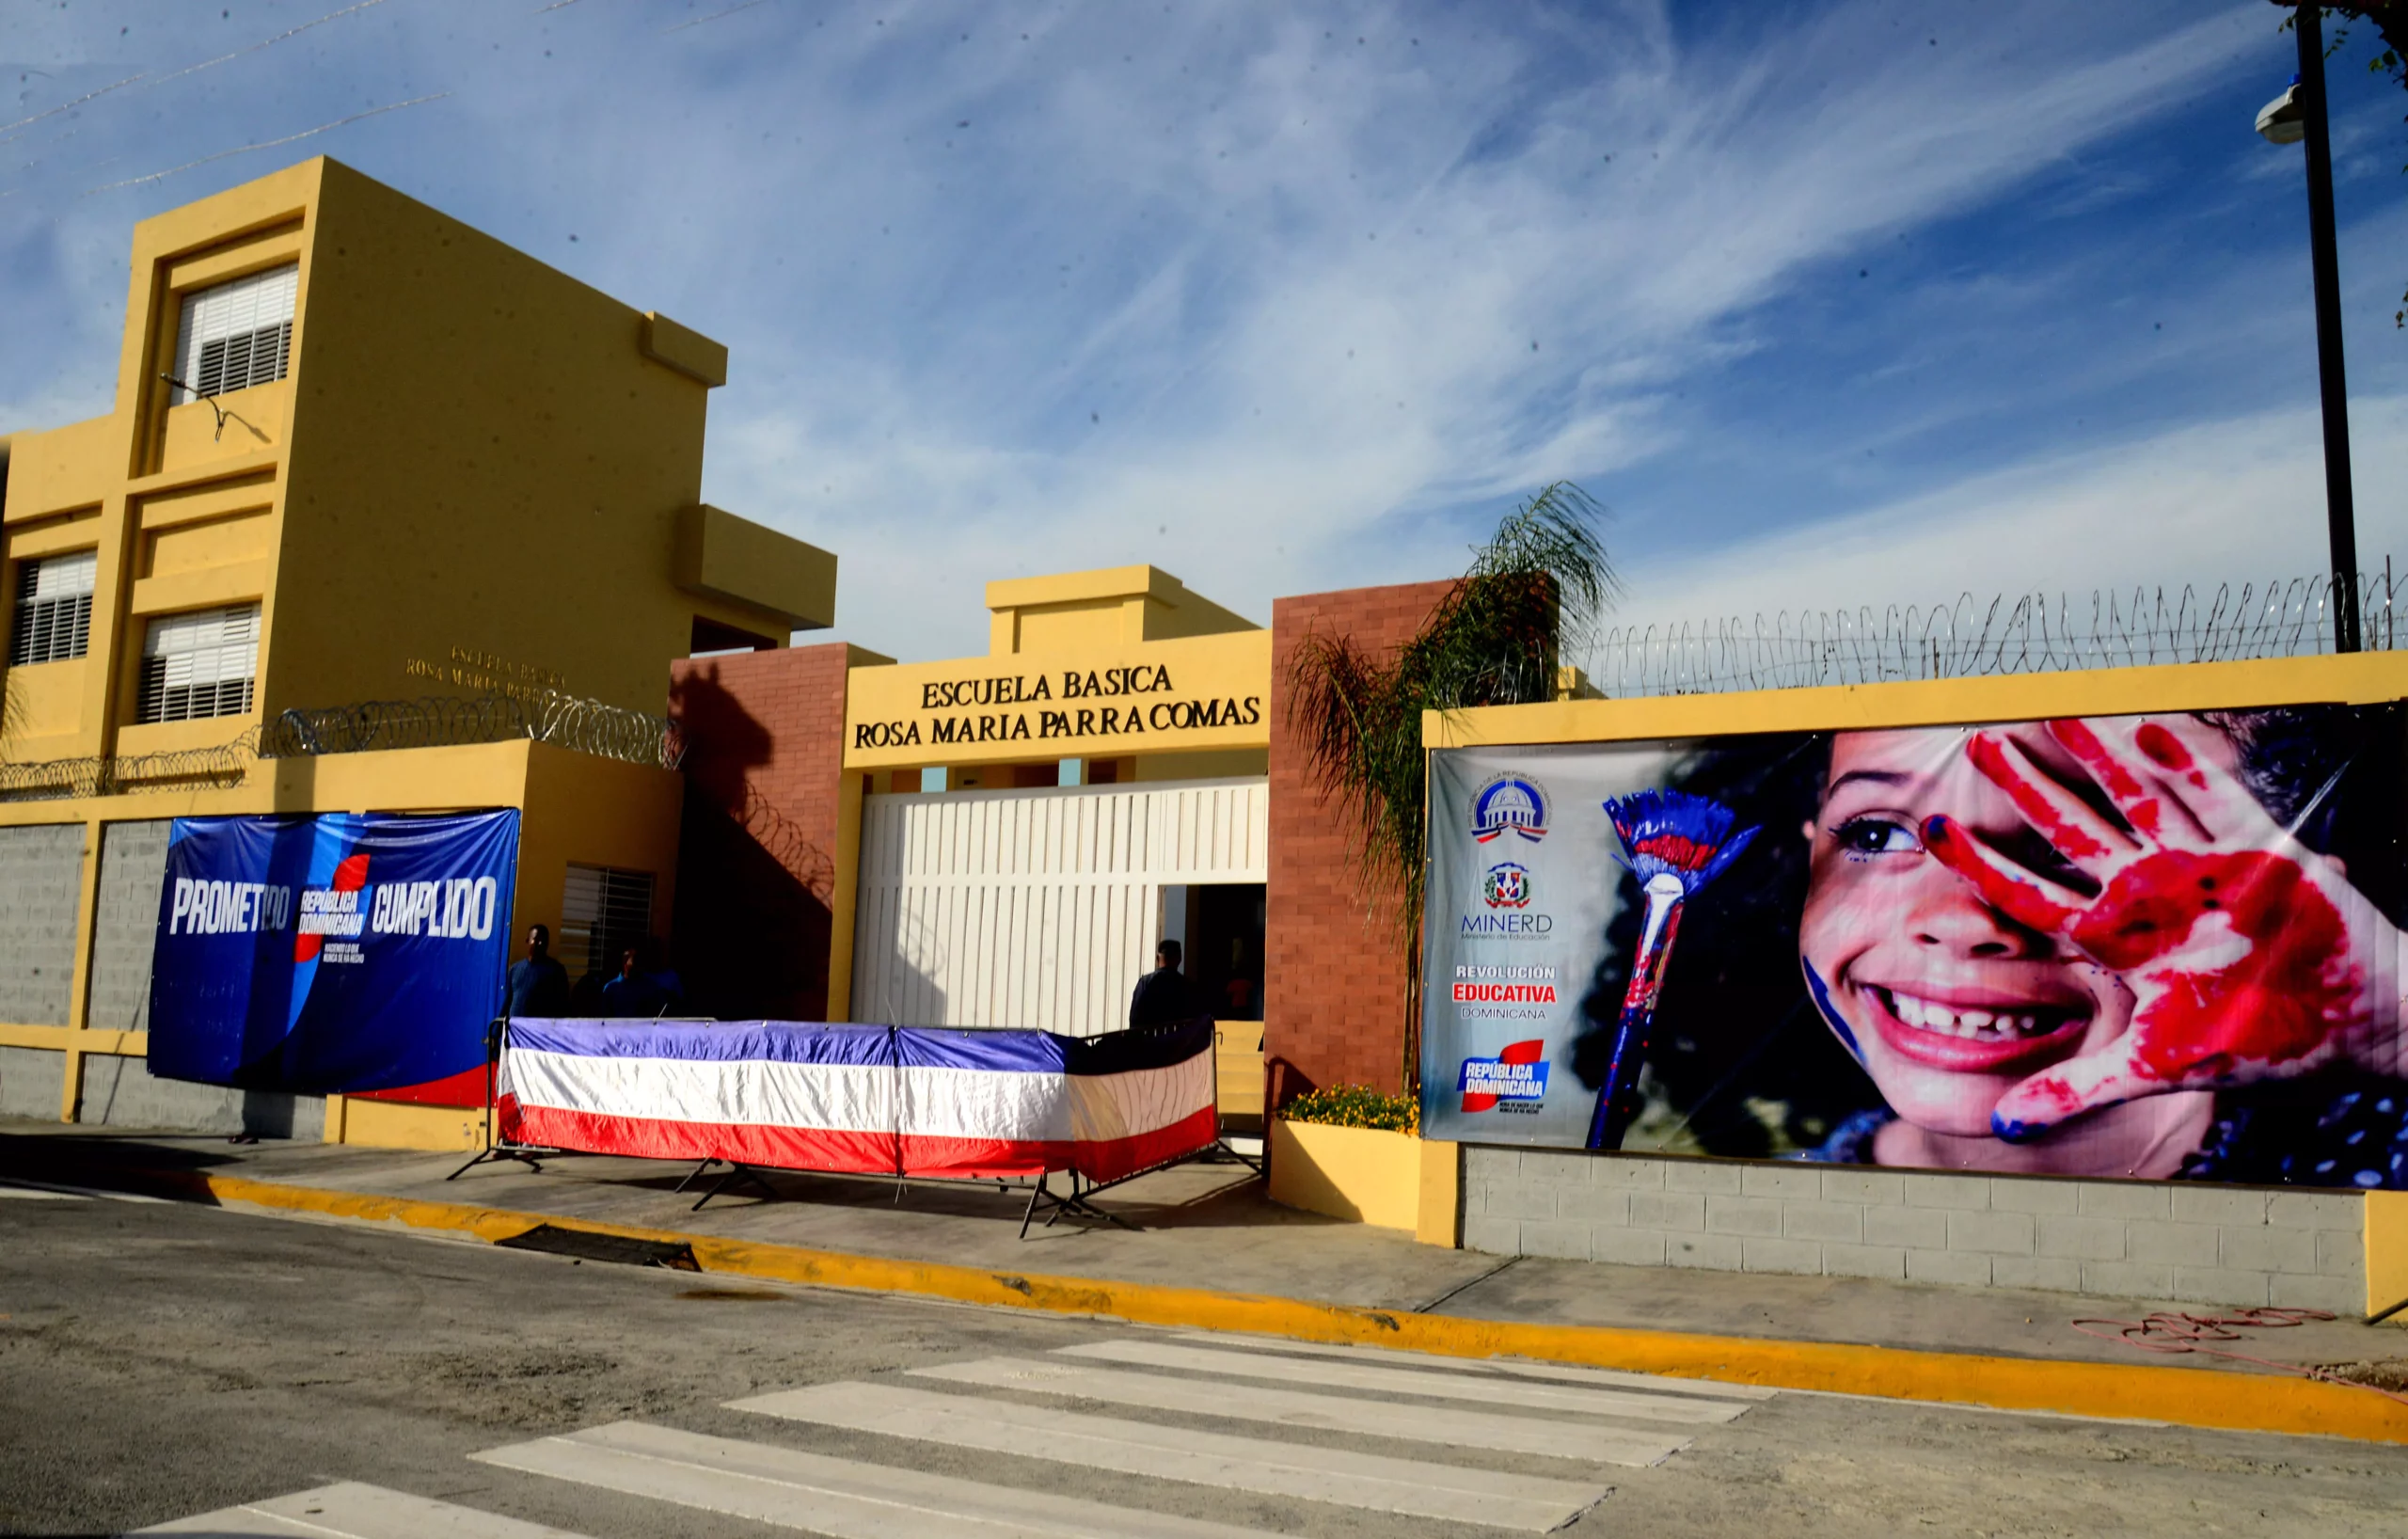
[265,162,785,713]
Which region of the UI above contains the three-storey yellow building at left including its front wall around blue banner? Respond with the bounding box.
[0,159,835,1144]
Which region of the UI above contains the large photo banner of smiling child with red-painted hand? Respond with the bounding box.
[1420,704,2408,1187]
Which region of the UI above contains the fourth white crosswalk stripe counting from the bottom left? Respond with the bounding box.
[912,1358,1688,1465]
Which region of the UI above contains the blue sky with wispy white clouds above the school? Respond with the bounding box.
[0,0,2408,658]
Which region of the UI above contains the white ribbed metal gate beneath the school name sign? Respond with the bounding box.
[852,775,1272,1036]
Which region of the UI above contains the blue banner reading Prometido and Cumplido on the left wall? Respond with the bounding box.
[150,812,517,1096]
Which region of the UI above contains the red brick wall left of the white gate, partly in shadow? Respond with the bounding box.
[670,641,850,1022]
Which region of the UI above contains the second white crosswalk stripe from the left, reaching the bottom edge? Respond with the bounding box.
[469,1421,1291,1539]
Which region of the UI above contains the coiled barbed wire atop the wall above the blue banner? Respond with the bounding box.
[0,693,687,802]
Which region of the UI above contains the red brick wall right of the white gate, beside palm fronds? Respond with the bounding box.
[1261,583,1452,1105]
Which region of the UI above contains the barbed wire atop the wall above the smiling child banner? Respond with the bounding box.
[1590,559,2408,698]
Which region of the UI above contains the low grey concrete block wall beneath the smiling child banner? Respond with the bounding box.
[1462,1144,2367,1315]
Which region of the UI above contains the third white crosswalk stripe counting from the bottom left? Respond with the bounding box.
[730,1383,1607,1534]
